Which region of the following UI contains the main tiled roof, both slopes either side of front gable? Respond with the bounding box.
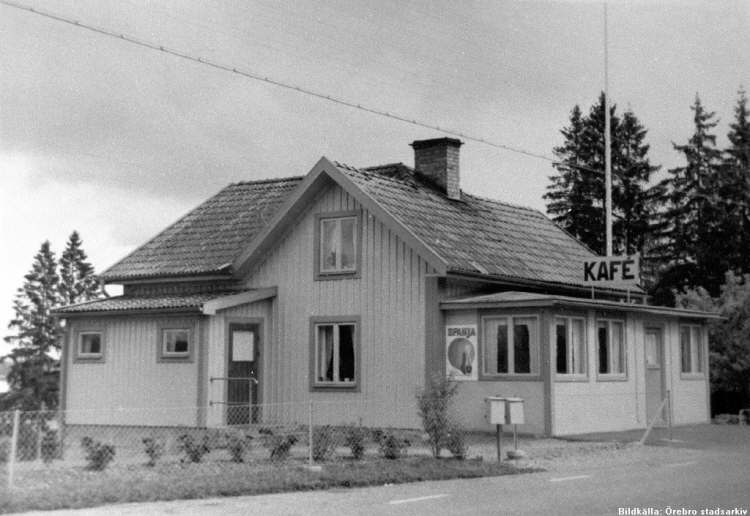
[103,159,612,285]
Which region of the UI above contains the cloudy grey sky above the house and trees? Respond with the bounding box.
[0,0,750,353]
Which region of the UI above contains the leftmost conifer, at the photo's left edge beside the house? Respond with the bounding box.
[2,242,61,410]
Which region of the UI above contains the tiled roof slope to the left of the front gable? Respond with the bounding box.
[101,177,303,281]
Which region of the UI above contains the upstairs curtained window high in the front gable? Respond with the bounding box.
[315,213,360,279]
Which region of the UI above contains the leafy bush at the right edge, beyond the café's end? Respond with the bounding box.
[677,272,750,406]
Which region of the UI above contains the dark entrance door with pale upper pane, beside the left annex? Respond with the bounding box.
[227,324,260,425]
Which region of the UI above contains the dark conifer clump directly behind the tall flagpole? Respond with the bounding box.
[544,94,659,254]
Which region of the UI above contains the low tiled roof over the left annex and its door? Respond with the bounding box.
[52,287,276,317]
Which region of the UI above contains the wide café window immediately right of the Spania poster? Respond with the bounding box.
[482,316,539,375]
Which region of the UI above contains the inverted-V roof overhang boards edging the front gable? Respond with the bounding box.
[232,157,448,278]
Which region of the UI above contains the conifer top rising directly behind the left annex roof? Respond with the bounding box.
[59,231,102,305]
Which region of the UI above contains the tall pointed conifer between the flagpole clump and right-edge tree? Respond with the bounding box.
[653,95,736,304]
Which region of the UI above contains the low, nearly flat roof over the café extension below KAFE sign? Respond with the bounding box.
[440,291,721,319]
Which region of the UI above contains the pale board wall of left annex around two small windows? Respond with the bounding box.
[66,317,203,426]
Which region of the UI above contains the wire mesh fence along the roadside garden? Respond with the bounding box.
[0,401,466,493]
